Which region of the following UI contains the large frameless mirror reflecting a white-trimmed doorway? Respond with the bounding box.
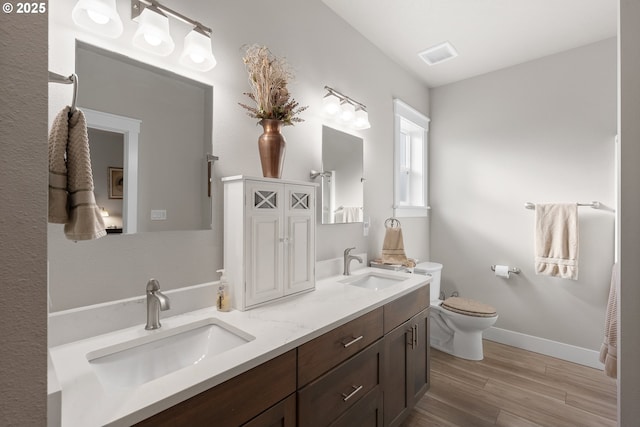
[76,42,213,234]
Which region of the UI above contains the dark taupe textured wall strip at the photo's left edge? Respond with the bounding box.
[0,3,48,427]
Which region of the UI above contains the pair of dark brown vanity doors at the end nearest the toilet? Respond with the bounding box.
[384,309,430,427]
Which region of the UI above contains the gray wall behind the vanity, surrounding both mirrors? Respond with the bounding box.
[49,0,429,311]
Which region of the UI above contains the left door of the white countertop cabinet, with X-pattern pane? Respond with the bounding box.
[246,181,284,306]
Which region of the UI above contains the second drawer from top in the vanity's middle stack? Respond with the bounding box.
[298,340,383,427]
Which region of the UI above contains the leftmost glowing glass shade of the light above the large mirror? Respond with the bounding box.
[71,0,122,38]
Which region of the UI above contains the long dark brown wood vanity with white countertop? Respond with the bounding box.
[50,268,430,427]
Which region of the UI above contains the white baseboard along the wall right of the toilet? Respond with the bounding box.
[482,327,604,370]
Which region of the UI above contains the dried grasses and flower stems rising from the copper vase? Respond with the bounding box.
[238,44,307,125]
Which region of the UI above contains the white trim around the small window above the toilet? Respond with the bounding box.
[393,99,431,218]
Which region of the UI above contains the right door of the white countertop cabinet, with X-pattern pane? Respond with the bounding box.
[284,185,315,295]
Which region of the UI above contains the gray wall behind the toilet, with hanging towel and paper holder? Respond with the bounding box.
[430,38,616,350]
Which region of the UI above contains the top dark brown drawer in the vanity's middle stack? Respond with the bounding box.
[298,310,382,387]
